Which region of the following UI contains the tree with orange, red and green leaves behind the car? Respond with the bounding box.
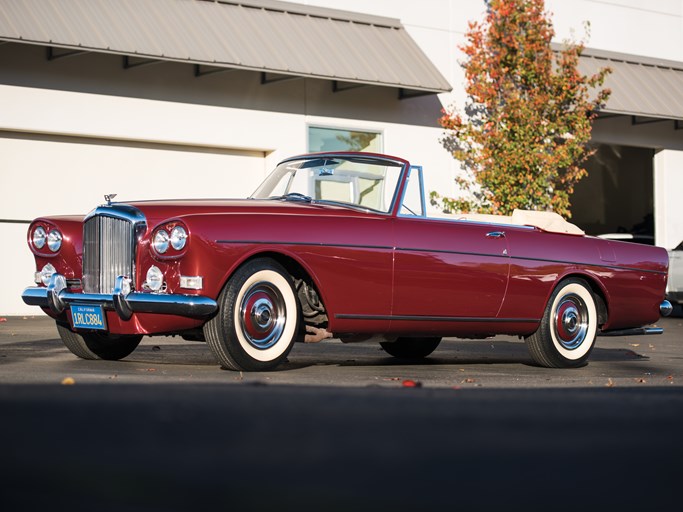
[440,0,610,217]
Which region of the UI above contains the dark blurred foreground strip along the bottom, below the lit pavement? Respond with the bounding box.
[0,383,683,512]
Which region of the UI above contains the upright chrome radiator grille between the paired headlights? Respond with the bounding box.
[83,215,135,293]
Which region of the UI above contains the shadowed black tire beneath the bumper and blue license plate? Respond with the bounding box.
[57,324,142,361]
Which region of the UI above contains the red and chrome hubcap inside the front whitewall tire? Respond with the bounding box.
[239,282,285,350]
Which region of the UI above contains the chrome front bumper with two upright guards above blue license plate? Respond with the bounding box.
[21,273,218,320]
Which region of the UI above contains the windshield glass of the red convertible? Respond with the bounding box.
[252,156,403,213]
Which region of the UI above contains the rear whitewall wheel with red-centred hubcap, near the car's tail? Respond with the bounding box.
[526,279,598,368]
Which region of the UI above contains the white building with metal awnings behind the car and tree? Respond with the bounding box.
[0,0,683,315]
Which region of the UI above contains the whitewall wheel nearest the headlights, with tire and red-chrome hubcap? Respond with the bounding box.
[204,258,300,371]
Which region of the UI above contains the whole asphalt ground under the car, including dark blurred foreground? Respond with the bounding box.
[0,317,683,511]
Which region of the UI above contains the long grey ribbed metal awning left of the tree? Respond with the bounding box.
[0,0,451,93]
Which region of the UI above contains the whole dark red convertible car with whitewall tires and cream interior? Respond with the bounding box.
[23,153,671,371]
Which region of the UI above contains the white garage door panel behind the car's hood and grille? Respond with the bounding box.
[0,134,266,220]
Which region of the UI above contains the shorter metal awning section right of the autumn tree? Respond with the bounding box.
[579,49,683,120]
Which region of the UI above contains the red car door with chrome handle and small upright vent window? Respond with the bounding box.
[392,167,510,321]
